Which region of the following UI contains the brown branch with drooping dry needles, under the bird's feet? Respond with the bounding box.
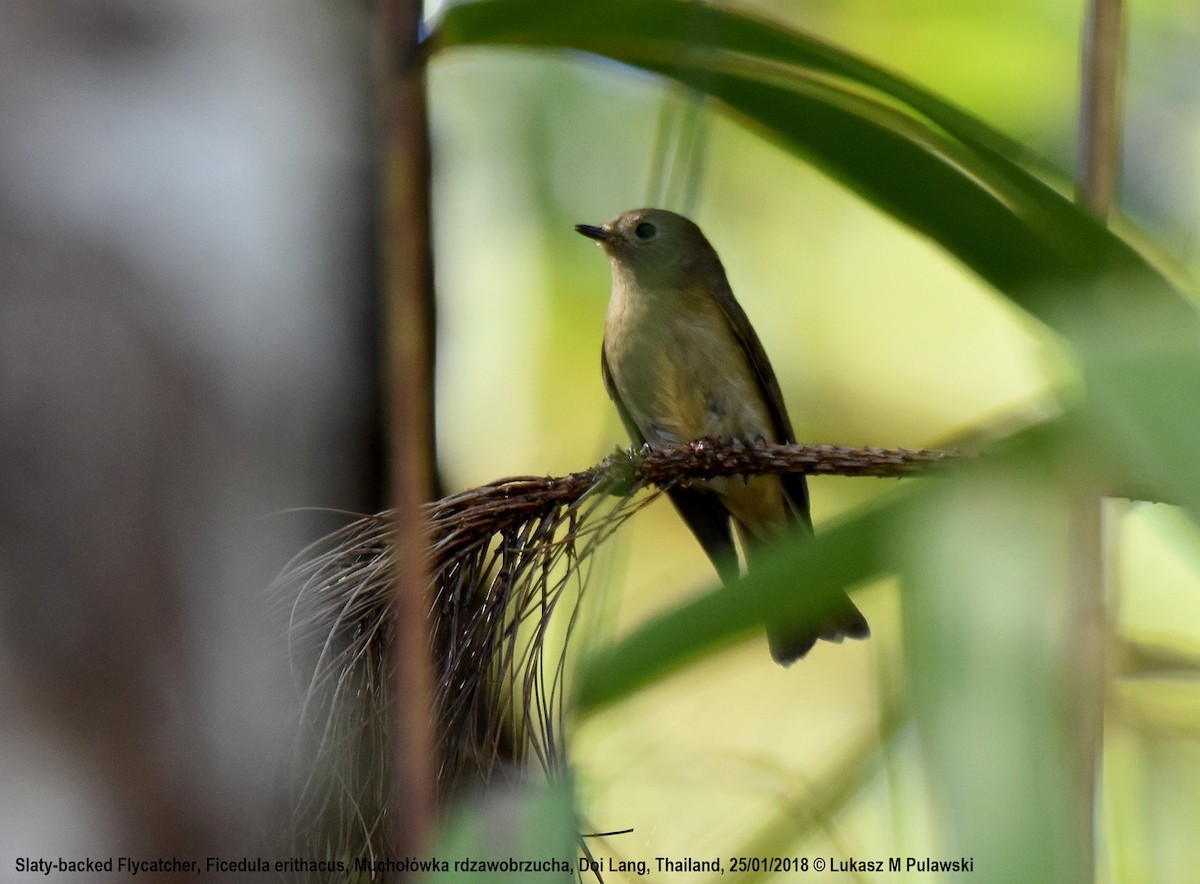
[281,440,956,855]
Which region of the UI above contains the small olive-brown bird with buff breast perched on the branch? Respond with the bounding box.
[575,209,870,666]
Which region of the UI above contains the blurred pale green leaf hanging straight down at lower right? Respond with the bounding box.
[894,447,1088,882]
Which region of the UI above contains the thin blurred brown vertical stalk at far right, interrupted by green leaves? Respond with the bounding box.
[1066,0,1124,882]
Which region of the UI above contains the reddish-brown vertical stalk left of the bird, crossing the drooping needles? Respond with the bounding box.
[379,0,438,856]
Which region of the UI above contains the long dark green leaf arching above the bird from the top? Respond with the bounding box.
[431,0,1171,299]
